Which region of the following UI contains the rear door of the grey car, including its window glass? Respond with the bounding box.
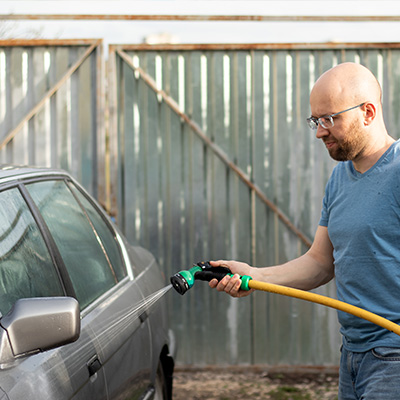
[26,180,152,399]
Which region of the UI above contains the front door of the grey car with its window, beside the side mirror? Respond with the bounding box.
[0,185,107,400]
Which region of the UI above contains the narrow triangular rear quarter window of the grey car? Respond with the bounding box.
[70,184,126,281]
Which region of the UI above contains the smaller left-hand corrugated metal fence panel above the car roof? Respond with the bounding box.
[0,40,105,200]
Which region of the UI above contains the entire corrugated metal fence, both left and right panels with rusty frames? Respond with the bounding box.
[0,41,400,365]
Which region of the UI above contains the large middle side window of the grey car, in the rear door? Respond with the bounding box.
[26,181,118,309]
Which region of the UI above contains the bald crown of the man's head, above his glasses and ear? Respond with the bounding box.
[310,63,382,112]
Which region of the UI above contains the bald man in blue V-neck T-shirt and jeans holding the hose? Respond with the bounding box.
[210,63,400,400]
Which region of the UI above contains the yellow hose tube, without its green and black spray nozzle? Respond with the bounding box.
[248,279,400,336]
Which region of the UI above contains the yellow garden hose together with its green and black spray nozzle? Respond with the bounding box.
[171,261,400,336]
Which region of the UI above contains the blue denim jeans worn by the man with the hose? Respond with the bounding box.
[339,347,400,400]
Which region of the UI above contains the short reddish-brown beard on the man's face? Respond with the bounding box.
[324,121,367,161]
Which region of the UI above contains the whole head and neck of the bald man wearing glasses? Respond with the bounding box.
[310,63,394,173]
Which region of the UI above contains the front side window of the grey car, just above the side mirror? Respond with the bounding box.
[0,188,64,315]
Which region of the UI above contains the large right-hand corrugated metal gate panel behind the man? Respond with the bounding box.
[110,44,400,365]
